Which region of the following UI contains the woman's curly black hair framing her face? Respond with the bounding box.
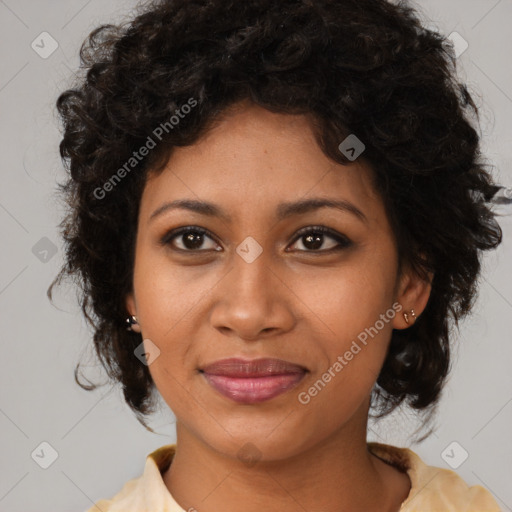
[48,0,502,432]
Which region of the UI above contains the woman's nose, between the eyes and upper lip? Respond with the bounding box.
[210,251,296,341]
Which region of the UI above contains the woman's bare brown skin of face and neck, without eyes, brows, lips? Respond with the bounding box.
[126,102,431,512]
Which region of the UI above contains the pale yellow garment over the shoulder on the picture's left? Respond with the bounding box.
[86,445,182,512]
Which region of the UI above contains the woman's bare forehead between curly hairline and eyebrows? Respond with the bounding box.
[141,103,383,223]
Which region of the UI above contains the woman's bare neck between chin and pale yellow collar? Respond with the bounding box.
[164,410,410,512]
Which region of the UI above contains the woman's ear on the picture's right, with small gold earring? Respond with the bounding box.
[393,267,434,329]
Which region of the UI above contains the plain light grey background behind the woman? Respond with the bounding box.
[0,0,512,512]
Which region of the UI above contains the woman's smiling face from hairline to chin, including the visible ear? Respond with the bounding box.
[127,100,429,460]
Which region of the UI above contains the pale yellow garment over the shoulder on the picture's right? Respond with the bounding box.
[368,443,501,512]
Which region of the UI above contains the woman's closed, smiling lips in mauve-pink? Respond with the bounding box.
[200,358,308,404]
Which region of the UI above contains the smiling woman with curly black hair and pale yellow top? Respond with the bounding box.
[49,0,501,512]
